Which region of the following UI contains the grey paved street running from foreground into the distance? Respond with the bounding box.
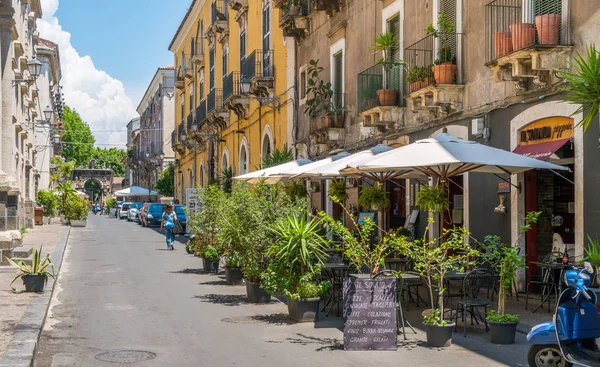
[35,215,527,367]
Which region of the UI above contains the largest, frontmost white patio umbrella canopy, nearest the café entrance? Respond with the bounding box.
[342,133,568,182]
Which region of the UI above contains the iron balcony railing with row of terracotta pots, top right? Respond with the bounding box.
[485,0,570,63]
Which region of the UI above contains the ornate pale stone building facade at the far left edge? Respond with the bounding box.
[0,0,43,262]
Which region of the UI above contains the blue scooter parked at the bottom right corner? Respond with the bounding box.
[527,263,600,367]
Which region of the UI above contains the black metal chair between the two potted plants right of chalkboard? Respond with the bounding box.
[454,269,496,337]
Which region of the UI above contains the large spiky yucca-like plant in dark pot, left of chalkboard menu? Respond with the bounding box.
[262,215,329,322]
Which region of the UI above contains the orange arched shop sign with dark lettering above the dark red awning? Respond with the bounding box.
[519,117,574,145]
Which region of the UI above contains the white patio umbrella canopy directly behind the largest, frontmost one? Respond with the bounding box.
[291,144,393,179]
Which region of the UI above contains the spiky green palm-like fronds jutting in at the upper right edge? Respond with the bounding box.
[560,45,600,131]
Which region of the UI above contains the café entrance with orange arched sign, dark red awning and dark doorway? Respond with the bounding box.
[514,117,575,282]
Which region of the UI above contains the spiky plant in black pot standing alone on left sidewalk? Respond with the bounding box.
[7,248,55,293]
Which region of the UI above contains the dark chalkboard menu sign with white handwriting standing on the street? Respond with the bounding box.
[344,278,398,350]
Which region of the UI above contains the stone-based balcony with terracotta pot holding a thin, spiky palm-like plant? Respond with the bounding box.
[357,63,405,130]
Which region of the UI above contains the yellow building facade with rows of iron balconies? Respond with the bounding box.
[169,0,295,203]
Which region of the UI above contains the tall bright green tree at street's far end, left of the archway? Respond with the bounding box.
[62,106,96,166]
